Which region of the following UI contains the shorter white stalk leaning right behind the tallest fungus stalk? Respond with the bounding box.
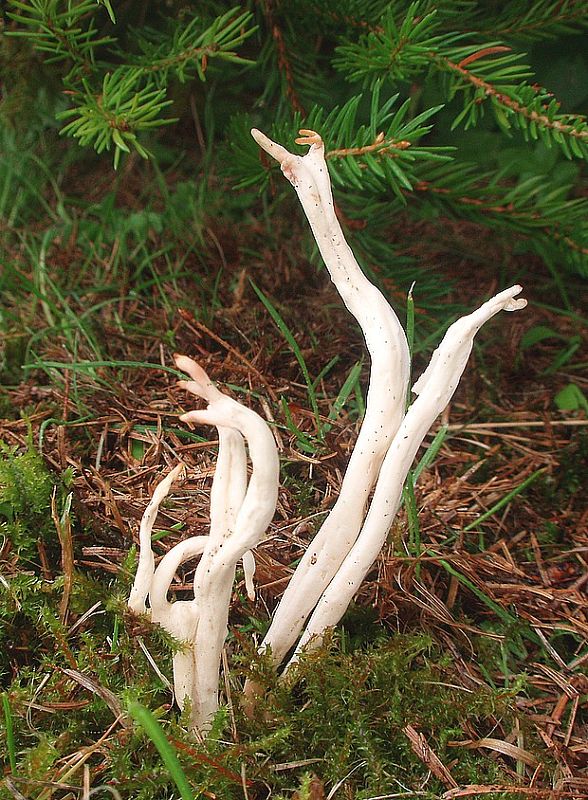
[289,286,527,665]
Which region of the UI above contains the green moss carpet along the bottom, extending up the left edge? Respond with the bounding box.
[0,448,545,800]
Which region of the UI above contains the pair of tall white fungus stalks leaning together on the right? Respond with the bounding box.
[246,129,526,680]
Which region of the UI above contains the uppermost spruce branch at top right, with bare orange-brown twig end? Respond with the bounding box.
[333,9,588,158]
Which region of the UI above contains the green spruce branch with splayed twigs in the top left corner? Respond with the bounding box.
[9,0,255,168]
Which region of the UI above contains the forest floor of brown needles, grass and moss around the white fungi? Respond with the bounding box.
[0,156,588,800]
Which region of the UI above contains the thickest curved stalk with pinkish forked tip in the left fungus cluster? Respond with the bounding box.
[176,356,279,731]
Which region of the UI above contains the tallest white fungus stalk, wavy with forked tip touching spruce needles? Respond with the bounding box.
[251,129,409,664]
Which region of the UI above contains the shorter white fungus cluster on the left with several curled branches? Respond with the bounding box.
[129,356,279,733]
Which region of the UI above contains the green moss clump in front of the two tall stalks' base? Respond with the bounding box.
[233,636,528,800]
